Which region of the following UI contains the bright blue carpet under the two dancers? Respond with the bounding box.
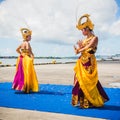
[0,83,120,120]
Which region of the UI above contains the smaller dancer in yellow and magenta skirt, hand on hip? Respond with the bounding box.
[12,28,38,93]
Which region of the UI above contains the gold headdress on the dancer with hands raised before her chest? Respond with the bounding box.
[76,14,94,30]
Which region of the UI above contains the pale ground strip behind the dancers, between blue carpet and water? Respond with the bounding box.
[0,61,120,88]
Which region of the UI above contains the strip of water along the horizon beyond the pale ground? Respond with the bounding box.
[0,55,120,65]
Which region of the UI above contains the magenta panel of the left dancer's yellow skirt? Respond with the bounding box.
[13,57,24,90]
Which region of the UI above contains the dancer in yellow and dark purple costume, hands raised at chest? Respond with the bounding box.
[72,14,109,108]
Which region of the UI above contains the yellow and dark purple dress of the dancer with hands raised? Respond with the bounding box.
[72,37,109,108]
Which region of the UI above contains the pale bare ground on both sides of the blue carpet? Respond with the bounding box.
[0,61,120,120]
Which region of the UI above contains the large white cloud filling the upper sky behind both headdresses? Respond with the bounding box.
[0,0,120,56]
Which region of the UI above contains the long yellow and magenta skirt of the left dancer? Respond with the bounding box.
[12,51,38,93]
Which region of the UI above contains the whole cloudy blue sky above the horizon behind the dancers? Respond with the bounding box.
[0,0,120,57]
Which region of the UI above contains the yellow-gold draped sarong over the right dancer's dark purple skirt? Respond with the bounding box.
[74,53,104,107]
